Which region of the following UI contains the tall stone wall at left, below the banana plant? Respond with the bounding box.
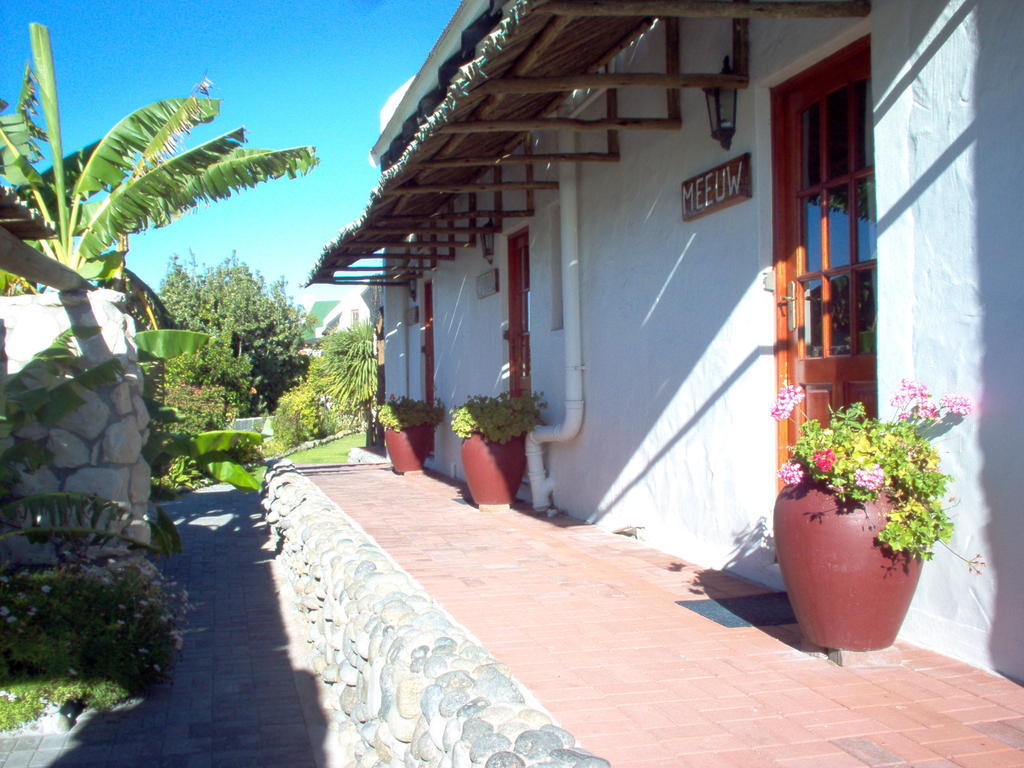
[0,290,150,552]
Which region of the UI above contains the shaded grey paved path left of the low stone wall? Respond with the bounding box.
[0,485,326,768]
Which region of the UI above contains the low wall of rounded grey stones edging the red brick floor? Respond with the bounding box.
[263,462,609,768]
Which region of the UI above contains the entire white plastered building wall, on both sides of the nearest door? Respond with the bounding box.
[380,0,1024,676]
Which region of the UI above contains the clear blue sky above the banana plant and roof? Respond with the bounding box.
[0,0,458,307]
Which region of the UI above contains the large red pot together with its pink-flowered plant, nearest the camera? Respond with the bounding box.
[772,379,981,651]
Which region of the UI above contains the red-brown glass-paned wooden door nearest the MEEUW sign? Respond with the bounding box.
[772,39,878,454]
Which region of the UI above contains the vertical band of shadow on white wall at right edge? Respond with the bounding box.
[973,2,1024,681]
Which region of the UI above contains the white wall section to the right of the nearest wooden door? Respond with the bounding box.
[871,0,1024,679]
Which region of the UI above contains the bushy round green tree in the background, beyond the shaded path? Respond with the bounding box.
[160,255,308,414]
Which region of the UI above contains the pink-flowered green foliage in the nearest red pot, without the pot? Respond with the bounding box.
[772,379,981,568]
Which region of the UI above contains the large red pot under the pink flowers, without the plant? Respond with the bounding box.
[775,482,922,650]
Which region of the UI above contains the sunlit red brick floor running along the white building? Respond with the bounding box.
[302,465,1024,768]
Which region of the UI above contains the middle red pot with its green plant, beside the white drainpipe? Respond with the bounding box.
[452,392,547,505]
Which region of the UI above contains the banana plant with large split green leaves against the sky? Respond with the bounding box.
[0,24,319,321]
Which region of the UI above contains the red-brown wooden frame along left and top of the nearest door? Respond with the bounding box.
[771,36,870,464]
